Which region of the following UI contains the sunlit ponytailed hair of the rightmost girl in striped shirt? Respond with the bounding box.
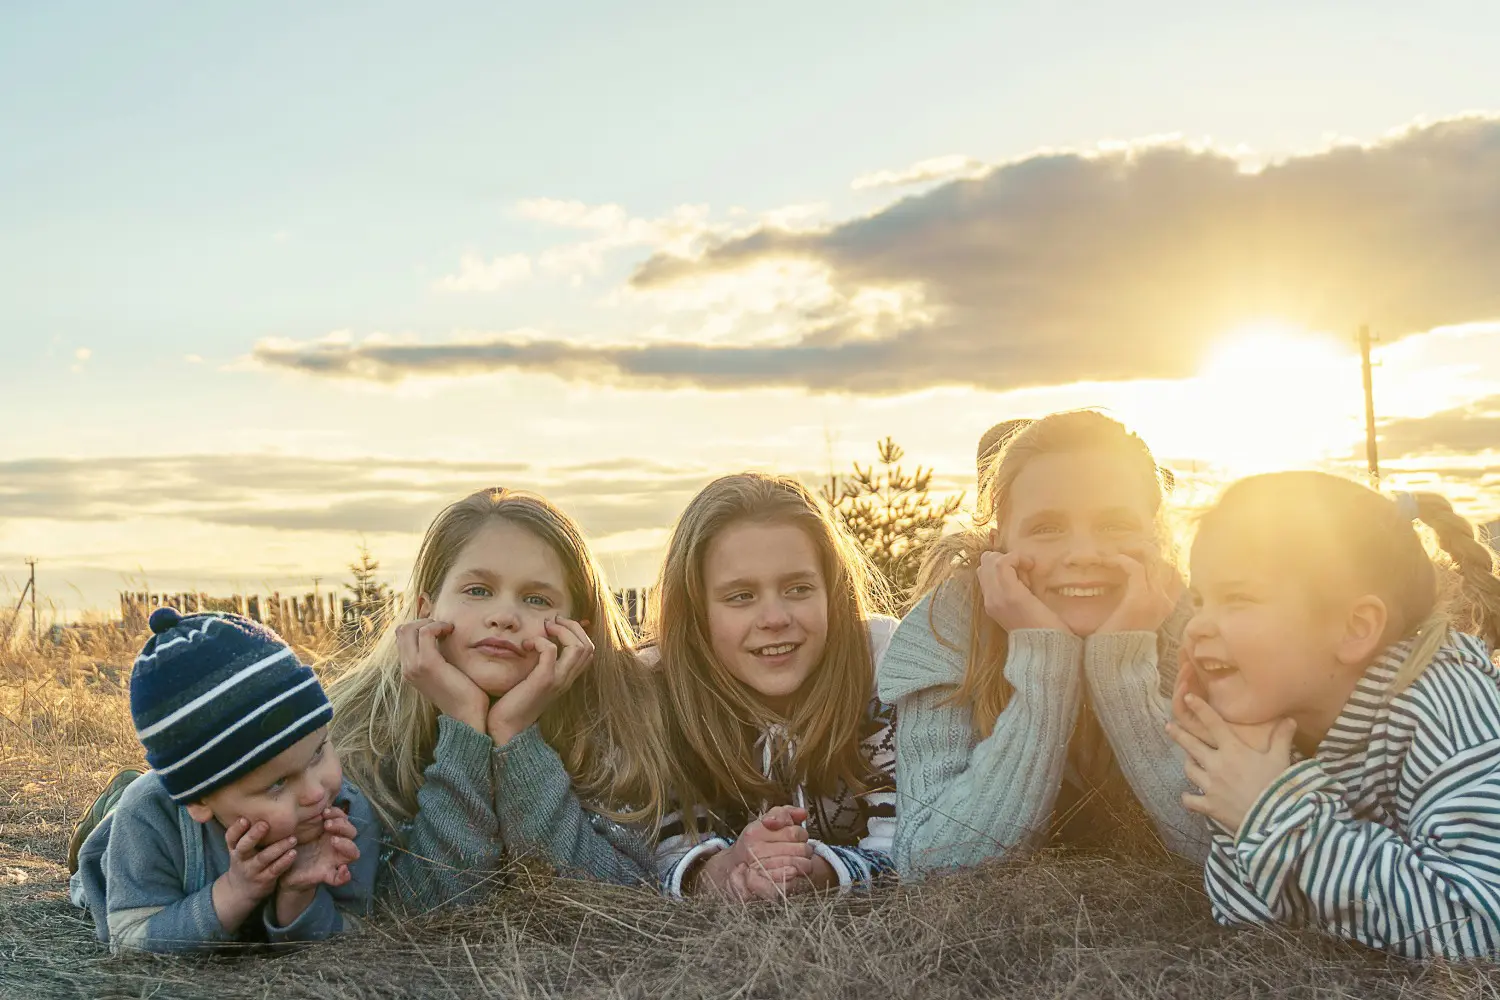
[1197,472,1500,690]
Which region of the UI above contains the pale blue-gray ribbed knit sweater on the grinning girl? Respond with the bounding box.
[878,580,1208,877]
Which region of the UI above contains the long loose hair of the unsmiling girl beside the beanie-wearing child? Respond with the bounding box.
[337,487,665,829]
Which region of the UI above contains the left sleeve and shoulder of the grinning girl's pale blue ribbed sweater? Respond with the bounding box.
[881,585,1083,877]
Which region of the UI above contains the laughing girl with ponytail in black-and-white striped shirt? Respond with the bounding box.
[1172,472,1500,958]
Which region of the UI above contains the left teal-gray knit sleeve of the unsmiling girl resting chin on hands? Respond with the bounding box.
[380,715,504,912]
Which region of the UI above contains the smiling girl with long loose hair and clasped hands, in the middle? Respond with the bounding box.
[648,472,896,900]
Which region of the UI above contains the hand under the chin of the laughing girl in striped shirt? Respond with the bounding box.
[1167,694,1296,834]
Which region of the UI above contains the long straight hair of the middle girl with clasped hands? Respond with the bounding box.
[648,472,884,829]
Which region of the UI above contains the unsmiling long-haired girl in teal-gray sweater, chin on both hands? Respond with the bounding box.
[337,487,665,906]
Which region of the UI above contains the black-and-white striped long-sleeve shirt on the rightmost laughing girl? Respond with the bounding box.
[1205,633,1500,958]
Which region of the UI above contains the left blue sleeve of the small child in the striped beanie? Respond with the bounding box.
[104,781,237,954]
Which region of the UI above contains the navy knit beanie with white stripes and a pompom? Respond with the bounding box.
[131,607,333,802]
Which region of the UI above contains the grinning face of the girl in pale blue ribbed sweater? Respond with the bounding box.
[1001,448,1158,636]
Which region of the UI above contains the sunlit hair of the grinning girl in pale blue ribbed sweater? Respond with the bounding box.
[915,409,1163,739]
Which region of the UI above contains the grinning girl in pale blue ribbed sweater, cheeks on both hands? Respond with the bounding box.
[879,411,1208,876]
